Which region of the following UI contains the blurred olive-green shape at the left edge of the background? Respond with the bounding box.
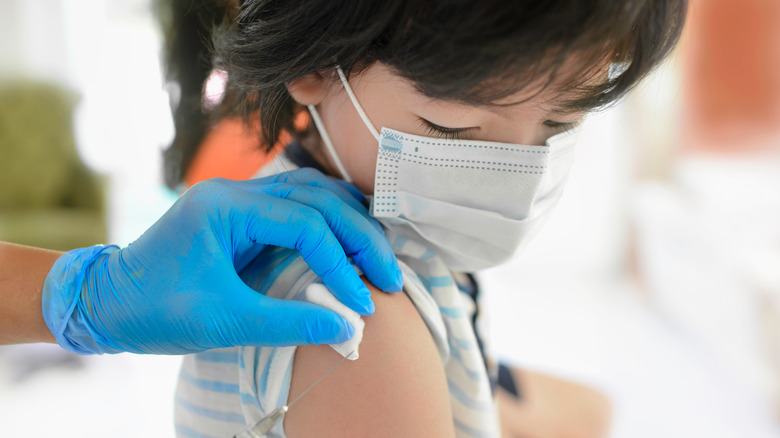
[0,79,107,250]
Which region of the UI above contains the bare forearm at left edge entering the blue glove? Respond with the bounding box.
[0,242,62,345]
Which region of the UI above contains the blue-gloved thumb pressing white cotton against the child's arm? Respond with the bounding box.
[224,286,355,346]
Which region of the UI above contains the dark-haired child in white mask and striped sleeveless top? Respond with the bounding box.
[176,0,686,437]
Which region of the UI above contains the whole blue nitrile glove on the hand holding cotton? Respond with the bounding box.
[42,169,402,354]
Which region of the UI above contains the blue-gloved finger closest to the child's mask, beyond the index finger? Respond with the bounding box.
[268,185,403,299]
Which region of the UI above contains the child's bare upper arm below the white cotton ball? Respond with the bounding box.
[284,279,455,438]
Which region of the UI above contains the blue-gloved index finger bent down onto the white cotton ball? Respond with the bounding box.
[232,192,374,315]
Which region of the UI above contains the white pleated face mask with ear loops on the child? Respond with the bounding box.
[309,67,578,272]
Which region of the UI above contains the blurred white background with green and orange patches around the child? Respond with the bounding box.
[0,0,780,438]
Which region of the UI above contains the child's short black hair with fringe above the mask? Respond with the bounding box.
[161,0,687,186]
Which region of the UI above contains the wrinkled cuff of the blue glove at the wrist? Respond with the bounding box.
[41,245,120,354]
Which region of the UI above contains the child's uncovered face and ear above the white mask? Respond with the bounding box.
[289,63,584,194]
